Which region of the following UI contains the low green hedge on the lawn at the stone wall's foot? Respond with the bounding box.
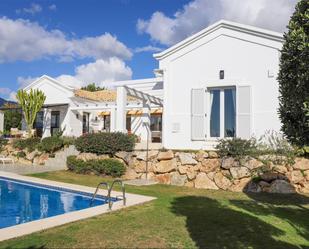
[67,156,125,177]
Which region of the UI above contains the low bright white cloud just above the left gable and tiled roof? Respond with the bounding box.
[17,57,132,88]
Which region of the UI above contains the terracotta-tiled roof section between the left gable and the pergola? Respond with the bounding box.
[74,89,136,102]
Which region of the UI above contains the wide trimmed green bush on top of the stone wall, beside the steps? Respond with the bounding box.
[75,132,135,155]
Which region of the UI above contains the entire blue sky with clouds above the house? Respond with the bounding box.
[0,0,297,99]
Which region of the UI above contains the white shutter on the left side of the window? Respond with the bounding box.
[191,88,206,141]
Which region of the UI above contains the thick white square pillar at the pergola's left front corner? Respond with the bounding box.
[116,86,127,133]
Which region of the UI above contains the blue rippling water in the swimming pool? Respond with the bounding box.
[0,177,107,229]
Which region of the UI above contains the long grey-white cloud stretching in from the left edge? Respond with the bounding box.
[0,17,132,63]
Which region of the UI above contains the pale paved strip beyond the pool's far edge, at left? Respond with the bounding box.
[0,164,66,175]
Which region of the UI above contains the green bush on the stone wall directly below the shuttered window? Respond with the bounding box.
[216,138,257,158]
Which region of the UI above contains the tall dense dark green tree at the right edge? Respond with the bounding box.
[278,0,309,146]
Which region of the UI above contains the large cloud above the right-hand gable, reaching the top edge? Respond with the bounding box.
[137,0,298,45]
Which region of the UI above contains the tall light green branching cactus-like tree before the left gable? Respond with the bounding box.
[16,89,46,136]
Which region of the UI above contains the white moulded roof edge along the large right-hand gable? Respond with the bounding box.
[153,20,283,60]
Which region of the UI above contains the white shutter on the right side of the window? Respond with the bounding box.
[236,86,252,139]
